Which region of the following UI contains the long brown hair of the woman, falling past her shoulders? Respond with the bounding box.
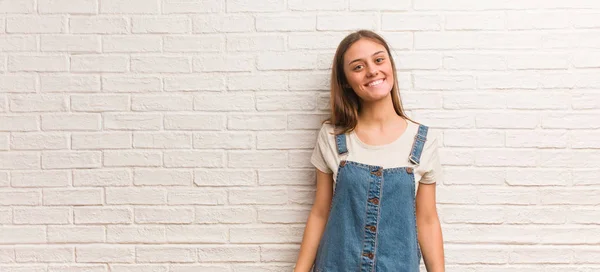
[323,30,414,134]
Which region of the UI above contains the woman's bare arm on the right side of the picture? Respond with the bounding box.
[416,183,445,272]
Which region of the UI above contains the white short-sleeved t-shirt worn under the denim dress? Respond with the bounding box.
[310,120,442,191]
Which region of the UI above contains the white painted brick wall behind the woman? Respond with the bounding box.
[0,0,600,272]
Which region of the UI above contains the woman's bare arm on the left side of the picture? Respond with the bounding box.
[294,169,333,272]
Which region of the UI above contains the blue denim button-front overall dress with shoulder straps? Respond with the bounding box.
[312,125,428,272]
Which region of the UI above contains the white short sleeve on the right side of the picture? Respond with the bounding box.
[419,130,443,184]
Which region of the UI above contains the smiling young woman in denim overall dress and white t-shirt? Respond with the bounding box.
[294,30,444,272]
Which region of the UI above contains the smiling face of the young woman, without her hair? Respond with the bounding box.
[344,38,394,101]
